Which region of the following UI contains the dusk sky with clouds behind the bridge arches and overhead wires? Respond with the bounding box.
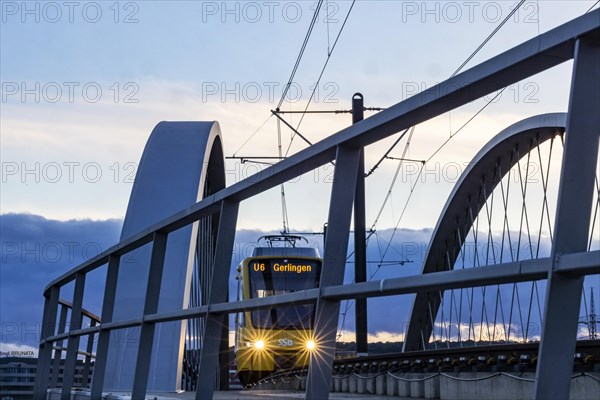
[0,0,600,351]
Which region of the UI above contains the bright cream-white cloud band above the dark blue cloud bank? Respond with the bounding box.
[0,72,564,228]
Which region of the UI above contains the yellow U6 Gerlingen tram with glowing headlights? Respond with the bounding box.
[235,235,322,387]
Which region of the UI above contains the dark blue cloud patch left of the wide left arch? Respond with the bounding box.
[0,214,122,346]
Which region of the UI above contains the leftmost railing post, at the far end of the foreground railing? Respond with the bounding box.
[33,286,60,399]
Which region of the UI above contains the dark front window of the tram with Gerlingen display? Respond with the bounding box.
[248,259,321,329]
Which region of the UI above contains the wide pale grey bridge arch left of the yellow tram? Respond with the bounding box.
[105,122,225,392]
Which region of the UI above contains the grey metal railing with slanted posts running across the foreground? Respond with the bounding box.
[35,11,600,399]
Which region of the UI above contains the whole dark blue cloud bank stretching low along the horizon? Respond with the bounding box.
[0,214,598,351]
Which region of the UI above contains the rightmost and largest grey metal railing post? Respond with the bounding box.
[534,38,600,399]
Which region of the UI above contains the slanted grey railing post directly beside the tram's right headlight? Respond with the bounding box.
[306,146,361,400]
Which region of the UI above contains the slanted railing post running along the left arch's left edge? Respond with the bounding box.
[91,255,121,400]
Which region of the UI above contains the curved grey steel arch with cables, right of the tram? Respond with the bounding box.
[404,113,567,351]
